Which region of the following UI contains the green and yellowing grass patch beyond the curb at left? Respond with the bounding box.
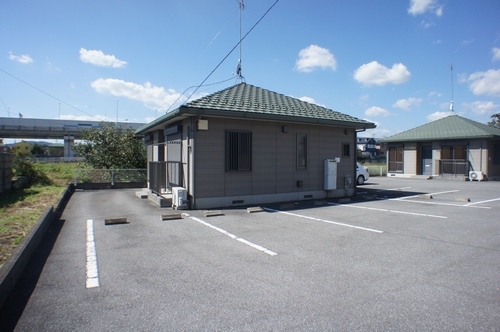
[0,163,81,267]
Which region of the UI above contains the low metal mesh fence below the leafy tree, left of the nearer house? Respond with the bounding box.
[73,168,147,185]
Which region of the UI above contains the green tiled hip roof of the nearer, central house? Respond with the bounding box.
[136,83,376,134]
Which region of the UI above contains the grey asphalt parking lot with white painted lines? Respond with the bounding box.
[0,177,500,331]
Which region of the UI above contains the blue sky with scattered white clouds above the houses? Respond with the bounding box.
[0,0,500,138]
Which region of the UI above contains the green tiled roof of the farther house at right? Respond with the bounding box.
[381,115,500,143]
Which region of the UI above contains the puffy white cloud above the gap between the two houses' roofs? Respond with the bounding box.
[354,61,411,86]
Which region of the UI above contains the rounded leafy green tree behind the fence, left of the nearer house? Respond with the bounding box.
[73,122,147,169]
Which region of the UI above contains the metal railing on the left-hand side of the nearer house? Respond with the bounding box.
[148,161,185,194]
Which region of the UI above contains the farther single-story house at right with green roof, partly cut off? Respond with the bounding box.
[382,114,500,180]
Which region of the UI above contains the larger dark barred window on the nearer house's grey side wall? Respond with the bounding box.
[226,130,252,172]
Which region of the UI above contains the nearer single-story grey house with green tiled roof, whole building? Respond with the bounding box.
[136,83,375,209]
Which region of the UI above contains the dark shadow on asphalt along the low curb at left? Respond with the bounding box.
[0,219,65,331]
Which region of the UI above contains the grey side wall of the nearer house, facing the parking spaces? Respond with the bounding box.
[194,118,356,208]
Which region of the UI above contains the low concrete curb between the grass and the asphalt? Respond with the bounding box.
[0,184,75,309]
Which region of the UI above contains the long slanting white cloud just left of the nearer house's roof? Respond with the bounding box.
[91,78,186,109]
